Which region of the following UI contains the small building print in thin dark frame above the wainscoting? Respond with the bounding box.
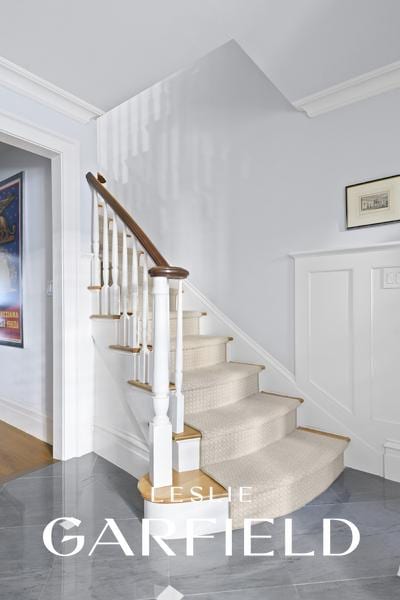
[346,175,400,229]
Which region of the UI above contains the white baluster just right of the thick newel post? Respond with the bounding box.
[171,279,185,433]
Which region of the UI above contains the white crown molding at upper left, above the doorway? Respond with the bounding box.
[0,56,104,123]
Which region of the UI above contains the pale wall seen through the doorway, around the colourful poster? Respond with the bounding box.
[0,144,53,438]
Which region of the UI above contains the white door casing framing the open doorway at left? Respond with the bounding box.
[0,111,86,460]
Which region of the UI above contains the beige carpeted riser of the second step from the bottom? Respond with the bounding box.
[200,410,296,466]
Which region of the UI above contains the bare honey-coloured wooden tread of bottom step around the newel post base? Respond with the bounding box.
[138,469,228,504]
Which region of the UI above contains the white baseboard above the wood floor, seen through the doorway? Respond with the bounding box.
[0,398,53,444]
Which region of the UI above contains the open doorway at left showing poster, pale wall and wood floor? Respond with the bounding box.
[0,142,53,479]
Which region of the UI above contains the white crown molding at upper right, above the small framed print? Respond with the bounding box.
[293,61,400,117]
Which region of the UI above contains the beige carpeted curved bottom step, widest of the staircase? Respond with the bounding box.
[203,429,349,529]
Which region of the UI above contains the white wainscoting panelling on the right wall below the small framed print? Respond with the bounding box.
[294,244,400,474]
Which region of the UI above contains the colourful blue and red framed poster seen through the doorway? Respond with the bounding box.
[0,173,24,348]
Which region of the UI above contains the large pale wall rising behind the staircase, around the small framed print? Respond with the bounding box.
[98,42,400,370]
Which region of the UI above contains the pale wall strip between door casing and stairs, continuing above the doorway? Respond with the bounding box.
[0,86,97,455]
